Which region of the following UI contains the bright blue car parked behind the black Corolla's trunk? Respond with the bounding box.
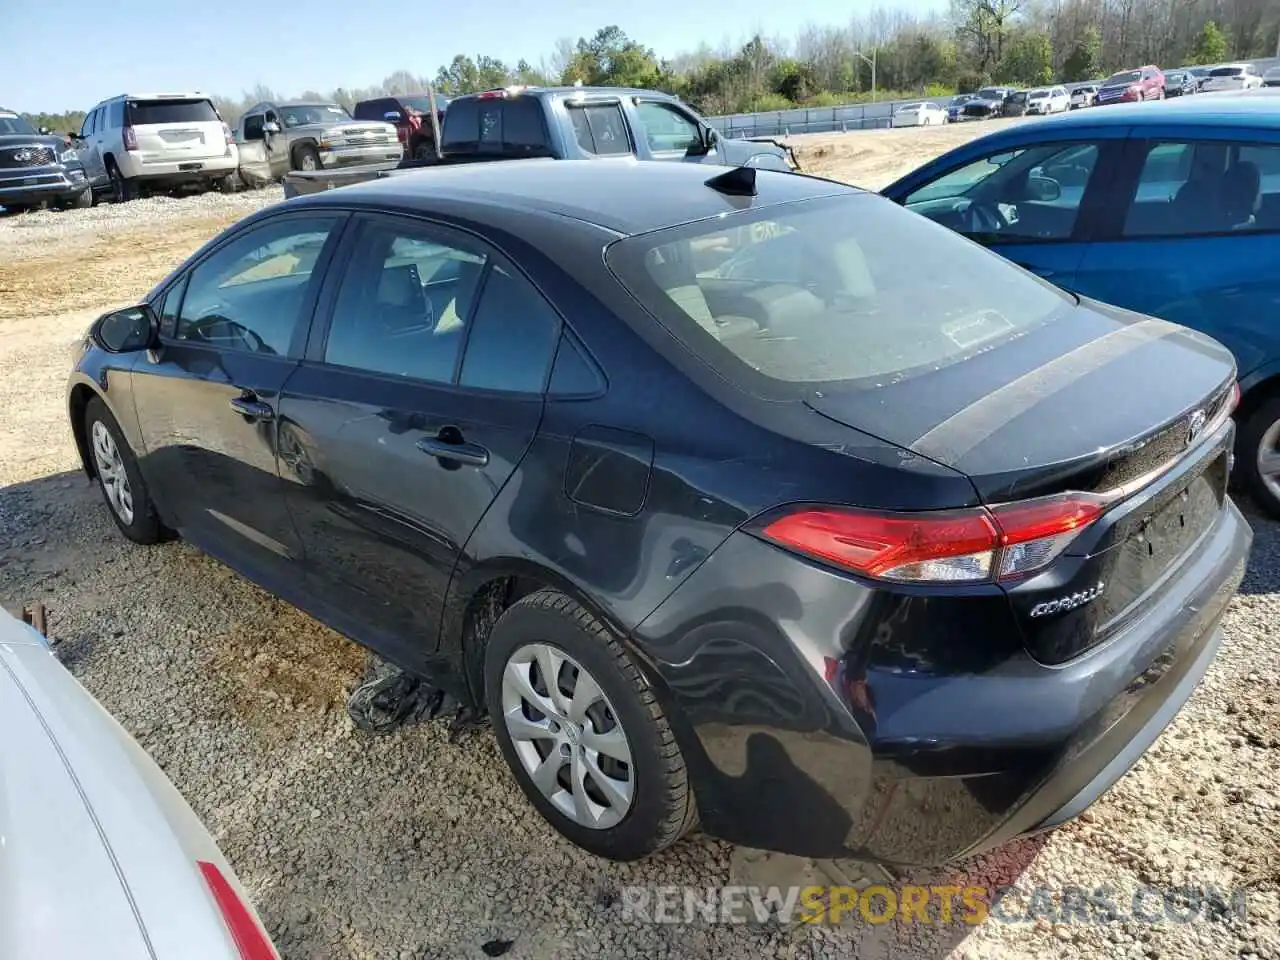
[883,90,1280,518]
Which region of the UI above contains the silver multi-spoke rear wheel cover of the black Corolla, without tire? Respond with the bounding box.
[502,643,635,829]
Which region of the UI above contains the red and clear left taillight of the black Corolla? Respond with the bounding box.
[759,493,1110,584]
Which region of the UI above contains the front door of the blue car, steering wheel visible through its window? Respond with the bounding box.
[883,124,1128,289]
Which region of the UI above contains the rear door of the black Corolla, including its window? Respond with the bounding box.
[280,215,559,669]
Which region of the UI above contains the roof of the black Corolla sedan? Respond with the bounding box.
[288,159,865,236]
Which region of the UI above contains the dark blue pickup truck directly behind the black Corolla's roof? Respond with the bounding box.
[284,87,799,197]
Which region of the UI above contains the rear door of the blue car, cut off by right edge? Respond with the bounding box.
[1075,125,1280,389]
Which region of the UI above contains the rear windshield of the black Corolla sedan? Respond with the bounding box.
[608,195,1074,393]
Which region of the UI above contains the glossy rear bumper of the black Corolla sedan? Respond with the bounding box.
[634,502,1252,867]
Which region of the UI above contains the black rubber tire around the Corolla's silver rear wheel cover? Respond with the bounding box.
[484,590,698,860]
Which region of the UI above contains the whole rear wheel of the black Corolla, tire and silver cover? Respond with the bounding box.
[485,590,696,860]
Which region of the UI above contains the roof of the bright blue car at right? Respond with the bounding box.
[977,88,1280,132]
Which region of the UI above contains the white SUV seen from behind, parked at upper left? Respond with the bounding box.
[76,93,239,201]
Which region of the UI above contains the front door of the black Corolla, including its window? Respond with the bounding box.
[133,214,343,588]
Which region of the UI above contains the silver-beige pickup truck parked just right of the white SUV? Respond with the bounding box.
[236,102,404,186]
